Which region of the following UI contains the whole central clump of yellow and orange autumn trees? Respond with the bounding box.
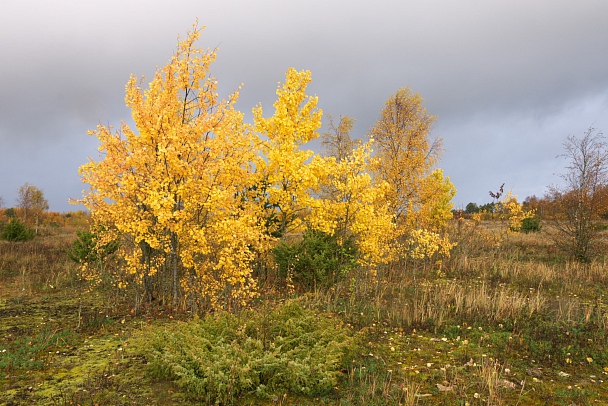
[77,23,455,309]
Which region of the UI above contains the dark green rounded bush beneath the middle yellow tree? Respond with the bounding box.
[273,230,357,288]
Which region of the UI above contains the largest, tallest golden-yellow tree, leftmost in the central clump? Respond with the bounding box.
[77,26,267,308]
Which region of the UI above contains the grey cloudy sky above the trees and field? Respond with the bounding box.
[0,0,608,211]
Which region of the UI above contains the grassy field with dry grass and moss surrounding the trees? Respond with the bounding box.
[0,221,608,405]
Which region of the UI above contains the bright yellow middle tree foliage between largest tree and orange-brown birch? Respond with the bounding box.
[253,72,393,276]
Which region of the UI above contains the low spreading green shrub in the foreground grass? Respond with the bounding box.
[136,302,353,404]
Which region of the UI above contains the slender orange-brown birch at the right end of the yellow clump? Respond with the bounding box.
[370,88,456,258]
